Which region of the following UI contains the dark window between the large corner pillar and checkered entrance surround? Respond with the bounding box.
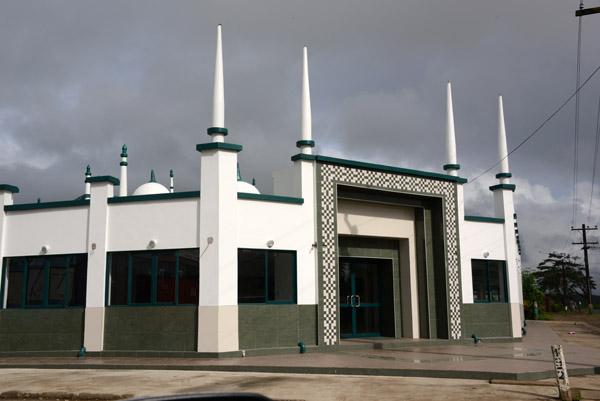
[238,249,296,304]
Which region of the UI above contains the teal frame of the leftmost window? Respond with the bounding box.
[0,253,88,310]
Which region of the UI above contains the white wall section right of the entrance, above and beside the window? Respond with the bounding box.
[460,221,506,304]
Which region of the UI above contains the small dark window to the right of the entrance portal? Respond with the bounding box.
[471,259,508,302]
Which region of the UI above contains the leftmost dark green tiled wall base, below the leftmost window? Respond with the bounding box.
[0,308,84,352]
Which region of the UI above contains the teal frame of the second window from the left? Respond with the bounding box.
[104,248,200,308]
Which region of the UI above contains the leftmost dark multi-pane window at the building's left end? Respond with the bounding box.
[2,254,87,308]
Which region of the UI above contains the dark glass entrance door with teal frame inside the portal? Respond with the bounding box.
[339,258,381,337]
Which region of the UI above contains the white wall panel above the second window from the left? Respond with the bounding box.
[108,198,200,252]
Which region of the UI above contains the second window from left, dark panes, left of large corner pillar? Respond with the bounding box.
[106,248,200,306]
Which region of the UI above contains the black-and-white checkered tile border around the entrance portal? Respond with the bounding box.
[317,164,462,345]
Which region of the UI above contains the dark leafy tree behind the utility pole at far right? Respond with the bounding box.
[535,252,596,302]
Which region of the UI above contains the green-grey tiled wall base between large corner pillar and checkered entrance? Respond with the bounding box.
[238,305,317,350]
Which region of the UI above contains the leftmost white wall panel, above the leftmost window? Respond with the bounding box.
[3,206,88,257]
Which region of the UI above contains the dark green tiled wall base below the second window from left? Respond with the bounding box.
[104,306,198,351]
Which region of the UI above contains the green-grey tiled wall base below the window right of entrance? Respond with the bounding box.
[461,303,510,338]
